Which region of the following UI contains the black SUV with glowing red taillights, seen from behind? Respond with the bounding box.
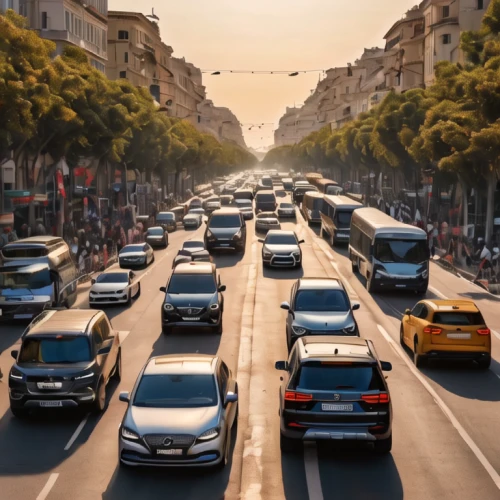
[276,336,392,453]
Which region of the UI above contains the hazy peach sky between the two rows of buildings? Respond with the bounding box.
[109,0,418,148]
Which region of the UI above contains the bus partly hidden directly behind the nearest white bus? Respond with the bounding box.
[320,194,363,246]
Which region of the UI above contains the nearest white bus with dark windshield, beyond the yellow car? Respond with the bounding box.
[349,208,430,294]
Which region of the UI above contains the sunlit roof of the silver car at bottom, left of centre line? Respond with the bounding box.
[144,354,218,375]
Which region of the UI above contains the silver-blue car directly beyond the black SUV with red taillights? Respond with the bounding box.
[281,278,360,350]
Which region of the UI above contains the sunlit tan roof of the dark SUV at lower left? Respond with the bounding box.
[26,309,102,337]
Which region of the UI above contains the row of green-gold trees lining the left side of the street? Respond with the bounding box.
[0,11,257,191]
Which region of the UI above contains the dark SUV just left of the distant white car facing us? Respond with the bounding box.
[204,208,247,252]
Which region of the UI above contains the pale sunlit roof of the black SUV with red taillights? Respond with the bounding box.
[298,335,375,363]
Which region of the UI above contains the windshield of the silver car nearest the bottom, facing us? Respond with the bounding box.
[133,374,218,408]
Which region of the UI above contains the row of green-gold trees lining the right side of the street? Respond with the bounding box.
[264,0,500,240]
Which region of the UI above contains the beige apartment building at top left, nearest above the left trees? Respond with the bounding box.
[21,0,108,72]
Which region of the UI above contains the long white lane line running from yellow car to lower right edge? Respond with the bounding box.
[377,325,500,490]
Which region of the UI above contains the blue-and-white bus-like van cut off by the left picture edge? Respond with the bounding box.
[0,236,78,321]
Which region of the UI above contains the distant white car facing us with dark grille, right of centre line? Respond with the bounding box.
[259,230,304,267]
